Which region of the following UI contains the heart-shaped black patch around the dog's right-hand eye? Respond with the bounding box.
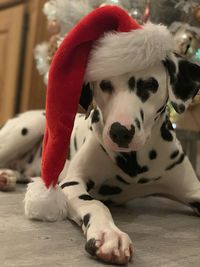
[137,77,159,102]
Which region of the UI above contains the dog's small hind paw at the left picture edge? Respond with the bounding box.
[0,169,17,191]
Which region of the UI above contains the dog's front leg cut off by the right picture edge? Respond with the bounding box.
[160,157,200,216]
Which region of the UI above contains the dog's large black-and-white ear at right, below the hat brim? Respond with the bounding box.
[163,53,200,113]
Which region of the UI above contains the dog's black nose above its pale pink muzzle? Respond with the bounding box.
[109,122,135,148]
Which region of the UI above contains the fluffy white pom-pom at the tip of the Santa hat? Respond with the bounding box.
[24,178,67,221]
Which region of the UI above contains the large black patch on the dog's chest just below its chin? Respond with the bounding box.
[116,151,148,177]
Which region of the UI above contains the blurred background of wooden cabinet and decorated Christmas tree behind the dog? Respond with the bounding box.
[0,0,200,173]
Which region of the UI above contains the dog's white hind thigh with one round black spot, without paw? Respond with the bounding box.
[0,110,45,169]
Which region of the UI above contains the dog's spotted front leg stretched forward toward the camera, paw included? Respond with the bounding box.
[60,178,133,264]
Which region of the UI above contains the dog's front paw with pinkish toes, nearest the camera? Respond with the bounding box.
[85,226,133,265]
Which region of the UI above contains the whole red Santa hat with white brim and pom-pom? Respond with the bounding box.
[25,6,173,220]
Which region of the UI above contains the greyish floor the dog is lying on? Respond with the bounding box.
[0,185,200,267]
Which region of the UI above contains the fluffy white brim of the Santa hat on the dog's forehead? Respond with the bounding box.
[85,23,174,81]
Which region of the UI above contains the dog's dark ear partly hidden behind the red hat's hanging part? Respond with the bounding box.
[79,83,93,117]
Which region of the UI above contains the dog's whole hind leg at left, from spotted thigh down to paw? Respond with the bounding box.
[0,110,45,191]
